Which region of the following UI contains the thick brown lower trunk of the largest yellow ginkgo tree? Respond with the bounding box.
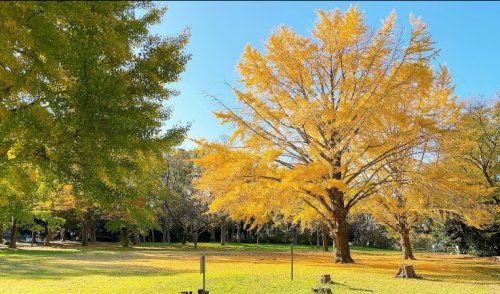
[329,211,354,263]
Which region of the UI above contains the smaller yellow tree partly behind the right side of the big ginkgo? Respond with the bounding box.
[361,146,492,259]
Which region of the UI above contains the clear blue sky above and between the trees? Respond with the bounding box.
[154,2,500,148]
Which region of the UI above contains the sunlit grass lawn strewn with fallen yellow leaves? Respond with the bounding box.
[0,243,500,294]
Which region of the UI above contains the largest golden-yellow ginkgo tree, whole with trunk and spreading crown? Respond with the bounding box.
[195,7,458,263]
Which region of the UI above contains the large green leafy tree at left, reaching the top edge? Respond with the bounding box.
[0,2,189,244]
